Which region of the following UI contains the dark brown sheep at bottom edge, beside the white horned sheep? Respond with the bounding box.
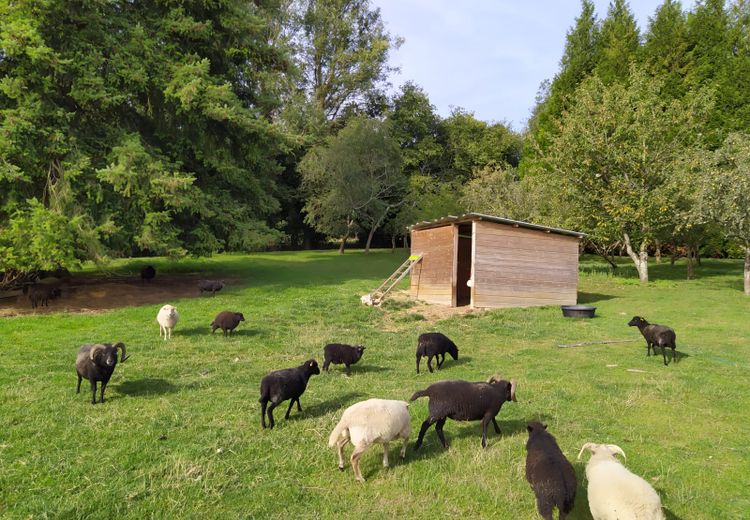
[526,421,578,520]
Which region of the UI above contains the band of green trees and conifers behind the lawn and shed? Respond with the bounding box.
[0,0,750,292]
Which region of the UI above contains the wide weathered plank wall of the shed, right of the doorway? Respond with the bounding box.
[472,221,578,307]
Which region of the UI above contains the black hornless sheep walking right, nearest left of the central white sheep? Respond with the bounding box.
[258,359,320,428]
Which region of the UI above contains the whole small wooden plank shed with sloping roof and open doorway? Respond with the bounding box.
[410,213,585,307]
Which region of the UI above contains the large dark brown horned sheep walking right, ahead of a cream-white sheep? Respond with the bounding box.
[409,376,516,450]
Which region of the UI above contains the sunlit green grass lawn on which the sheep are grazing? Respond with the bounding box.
[0,250,750,520]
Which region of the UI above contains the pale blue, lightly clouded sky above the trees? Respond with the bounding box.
[371,0,695,130]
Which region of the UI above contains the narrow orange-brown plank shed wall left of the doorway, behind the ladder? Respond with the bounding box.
[411,225,454,305]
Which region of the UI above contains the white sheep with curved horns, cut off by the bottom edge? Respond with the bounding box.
[578,442,664,520]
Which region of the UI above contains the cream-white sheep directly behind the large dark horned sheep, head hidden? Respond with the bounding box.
[328,399,411,482]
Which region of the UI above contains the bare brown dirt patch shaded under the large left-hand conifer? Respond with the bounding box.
[0,274,242,317]
